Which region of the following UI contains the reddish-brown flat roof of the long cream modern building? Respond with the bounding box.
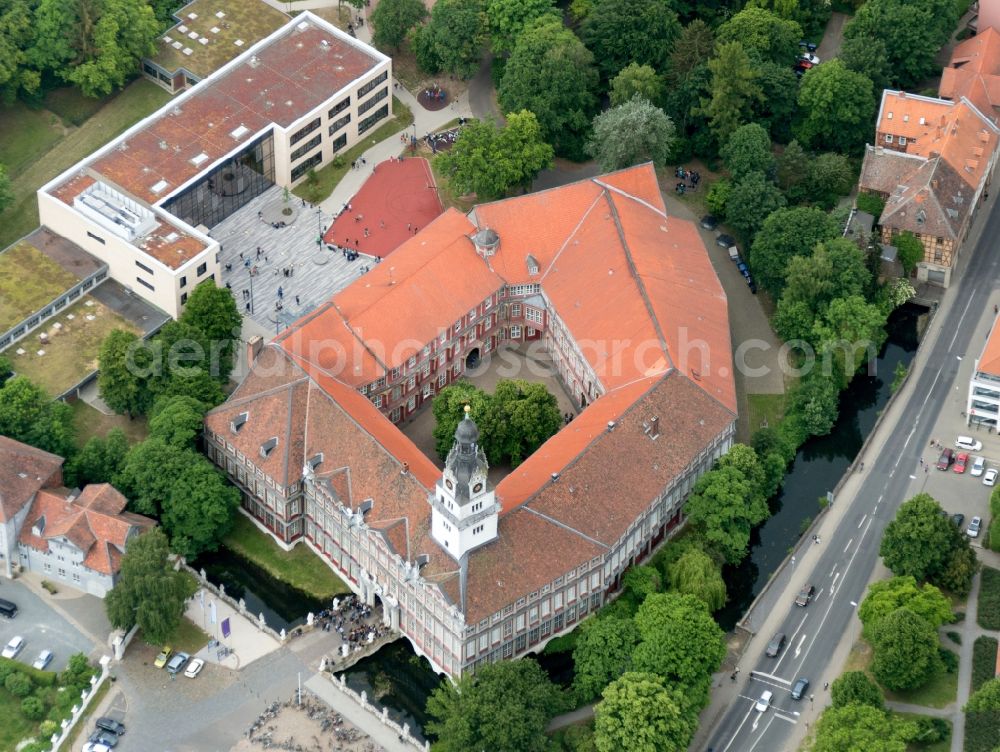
[42,13,389,269]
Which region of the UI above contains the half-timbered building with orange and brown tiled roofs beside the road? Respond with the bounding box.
[859,89,1000,287]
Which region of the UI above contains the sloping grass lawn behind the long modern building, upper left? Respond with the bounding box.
[0,78,170,248]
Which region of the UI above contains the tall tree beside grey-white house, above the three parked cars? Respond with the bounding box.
[104,528,191,645]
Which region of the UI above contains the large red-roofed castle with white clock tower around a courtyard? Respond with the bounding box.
[205,164,736,677]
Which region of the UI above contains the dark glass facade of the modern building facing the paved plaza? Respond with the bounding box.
[164,131,274,229]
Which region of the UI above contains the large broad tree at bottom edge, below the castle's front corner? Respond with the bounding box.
[427,658,566,752]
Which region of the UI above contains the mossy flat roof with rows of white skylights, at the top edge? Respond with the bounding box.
[149,0,288,79]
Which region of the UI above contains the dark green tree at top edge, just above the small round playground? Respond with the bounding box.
[413,0,486,78]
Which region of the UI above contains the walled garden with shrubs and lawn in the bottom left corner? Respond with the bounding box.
[0,653,97,752]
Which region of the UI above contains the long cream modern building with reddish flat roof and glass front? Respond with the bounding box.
[38,11,392,317]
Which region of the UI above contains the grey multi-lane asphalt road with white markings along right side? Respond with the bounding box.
[707,200,1000,752]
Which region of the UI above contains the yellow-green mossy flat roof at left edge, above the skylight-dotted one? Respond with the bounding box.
[0,242,79,332]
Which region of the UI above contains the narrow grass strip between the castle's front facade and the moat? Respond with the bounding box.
[222,514,351,600]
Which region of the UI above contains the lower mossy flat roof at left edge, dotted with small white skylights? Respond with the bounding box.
[5,295,140,397]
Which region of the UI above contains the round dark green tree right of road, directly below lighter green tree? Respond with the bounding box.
[868,607,944,691]
